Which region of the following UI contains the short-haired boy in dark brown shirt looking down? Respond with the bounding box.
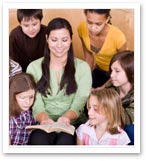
[9,9,46,72]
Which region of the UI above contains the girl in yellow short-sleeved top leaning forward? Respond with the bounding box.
[78,9,126,88]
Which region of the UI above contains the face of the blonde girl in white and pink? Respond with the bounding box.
[88,95,107,126]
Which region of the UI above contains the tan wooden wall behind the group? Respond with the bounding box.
[9,9,134,59]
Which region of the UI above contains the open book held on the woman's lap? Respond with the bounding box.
[26,122,75,135]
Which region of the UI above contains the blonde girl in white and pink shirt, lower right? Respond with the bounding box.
[76,89,130,145]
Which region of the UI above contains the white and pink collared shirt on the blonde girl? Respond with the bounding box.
[76,121,130,145]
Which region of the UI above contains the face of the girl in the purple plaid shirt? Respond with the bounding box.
[16,89,35,111]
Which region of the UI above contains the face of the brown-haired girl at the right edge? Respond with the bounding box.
[111,61,129,87]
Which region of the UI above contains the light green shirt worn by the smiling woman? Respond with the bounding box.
[27,57,92,124]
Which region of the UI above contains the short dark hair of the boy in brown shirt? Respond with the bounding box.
[17,9,43,23]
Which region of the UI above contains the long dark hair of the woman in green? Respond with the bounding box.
[37,18,77,96]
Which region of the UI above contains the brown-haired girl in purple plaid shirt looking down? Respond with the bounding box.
[9,73,36,145]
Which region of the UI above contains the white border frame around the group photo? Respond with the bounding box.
[2,2,140,153]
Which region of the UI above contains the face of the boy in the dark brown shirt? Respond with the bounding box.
[20,18,41,38]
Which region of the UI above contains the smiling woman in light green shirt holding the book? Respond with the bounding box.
[27,18,92,145]
